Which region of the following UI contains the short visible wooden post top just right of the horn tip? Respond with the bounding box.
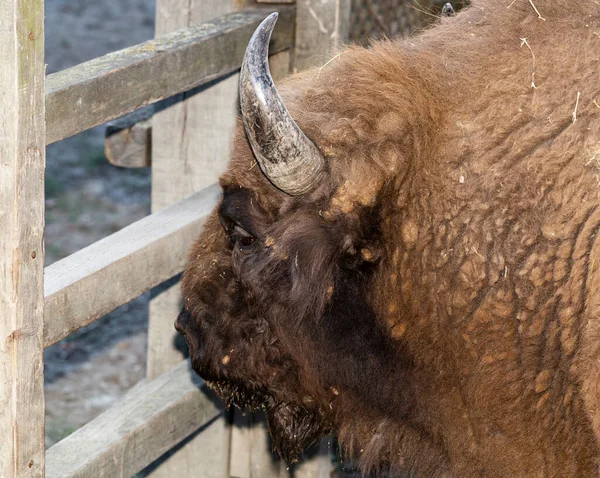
[294,0,351,71]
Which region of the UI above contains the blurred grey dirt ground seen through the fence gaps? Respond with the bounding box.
[44,0,154,446]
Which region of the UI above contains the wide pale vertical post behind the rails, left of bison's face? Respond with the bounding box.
[148,0,238,478]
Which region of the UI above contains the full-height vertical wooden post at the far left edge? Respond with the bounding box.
[0,0,46,478]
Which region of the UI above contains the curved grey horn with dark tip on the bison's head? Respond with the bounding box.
[240,13,325,196]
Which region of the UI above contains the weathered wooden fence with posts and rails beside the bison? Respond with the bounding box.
[0,0,350,478]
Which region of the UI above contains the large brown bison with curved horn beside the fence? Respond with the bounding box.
[176,0,600,478]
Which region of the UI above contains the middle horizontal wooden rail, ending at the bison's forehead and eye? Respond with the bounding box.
[44,185,220,347]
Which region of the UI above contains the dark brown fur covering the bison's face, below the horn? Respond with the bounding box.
[176,184,418,459]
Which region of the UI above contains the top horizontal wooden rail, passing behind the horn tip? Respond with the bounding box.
[46,6,295,144]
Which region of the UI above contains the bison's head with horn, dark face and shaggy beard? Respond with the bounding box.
[176,14,418,466]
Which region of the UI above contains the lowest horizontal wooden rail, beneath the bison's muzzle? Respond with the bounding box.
[46,360,222,478]
